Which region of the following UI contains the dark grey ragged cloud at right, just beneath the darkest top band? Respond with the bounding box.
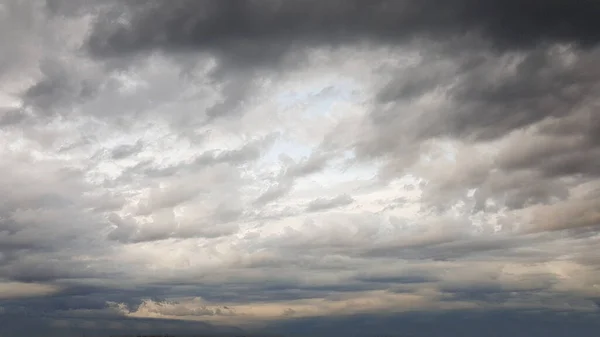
[446,45,597,139]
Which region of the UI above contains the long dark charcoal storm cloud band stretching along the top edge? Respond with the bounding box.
[89,0,600,59]
